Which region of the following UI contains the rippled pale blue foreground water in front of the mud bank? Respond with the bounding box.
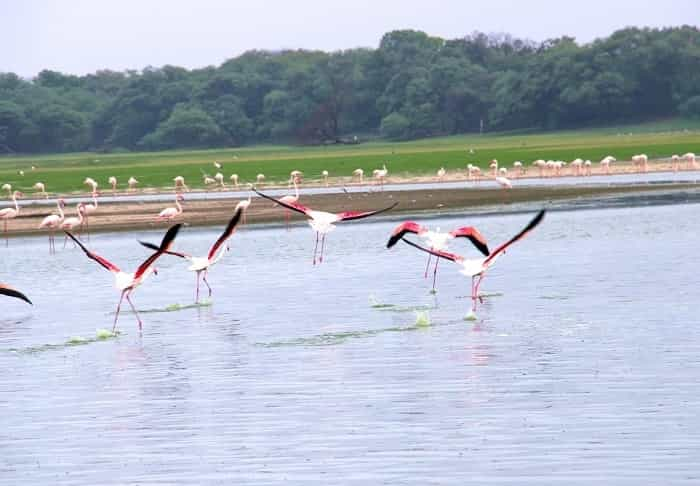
[0,204,700,485]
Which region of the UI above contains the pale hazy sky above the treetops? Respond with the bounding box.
[0,0,700,77]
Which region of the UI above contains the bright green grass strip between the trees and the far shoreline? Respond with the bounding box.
[0,120,700,194]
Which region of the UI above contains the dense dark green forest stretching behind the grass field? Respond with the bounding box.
[0,26,700,153]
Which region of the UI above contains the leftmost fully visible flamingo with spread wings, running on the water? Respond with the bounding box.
[66,224,182,332]
